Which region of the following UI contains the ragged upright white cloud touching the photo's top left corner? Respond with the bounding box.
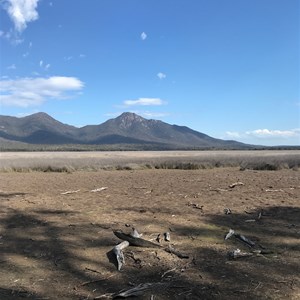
[0,0,39,33]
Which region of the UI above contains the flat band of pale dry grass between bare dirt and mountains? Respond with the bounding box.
[0,150,300,172]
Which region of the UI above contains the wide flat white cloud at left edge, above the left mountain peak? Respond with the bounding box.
[0,76,84,107]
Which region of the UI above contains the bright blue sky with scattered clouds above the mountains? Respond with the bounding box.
[0,0,300,145]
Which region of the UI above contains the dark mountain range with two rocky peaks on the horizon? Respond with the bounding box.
[0,112,254,150]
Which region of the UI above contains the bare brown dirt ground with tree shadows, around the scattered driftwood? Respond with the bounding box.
[0,152,300,299]
